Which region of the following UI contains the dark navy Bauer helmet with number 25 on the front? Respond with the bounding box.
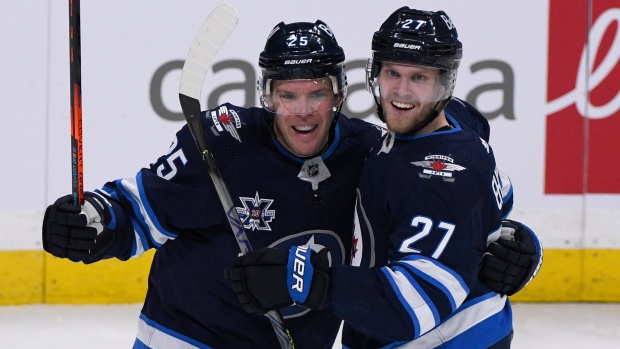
[258,20,347,115]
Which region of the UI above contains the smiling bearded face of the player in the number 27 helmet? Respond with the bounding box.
[378,63,445,134]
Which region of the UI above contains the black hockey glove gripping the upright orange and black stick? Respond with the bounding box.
[43,192,114,263]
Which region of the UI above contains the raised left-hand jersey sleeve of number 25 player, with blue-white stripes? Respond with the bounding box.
[89,113,226,260]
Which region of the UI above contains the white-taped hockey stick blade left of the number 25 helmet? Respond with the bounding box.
[179,4,238,100]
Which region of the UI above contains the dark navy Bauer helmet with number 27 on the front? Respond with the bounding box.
[366,6,463,122]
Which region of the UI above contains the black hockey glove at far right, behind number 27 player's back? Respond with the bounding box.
[478,220,543,296]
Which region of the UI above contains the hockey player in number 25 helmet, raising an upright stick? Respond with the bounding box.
[43,17,536,349]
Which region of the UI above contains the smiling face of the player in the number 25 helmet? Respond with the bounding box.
[270,78,340,157]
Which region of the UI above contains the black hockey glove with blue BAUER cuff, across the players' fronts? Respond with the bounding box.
[225,246,329,314]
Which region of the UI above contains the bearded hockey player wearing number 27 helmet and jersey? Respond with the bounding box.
[228,7,542,348]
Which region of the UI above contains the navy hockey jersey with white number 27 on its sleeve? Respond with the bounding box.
[326,100,512,348]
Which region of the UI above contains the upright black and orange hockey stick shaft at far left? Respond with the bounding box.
[69,0,84,206]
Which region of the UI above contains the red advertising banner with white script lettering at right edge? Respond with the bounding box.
[545,0,620,194]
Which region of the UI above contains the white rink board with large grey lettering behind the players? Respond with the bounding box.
[0,0,620,250]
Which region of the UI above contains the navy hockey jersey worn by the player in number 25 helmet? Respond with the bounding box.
[91,104,384,349]
